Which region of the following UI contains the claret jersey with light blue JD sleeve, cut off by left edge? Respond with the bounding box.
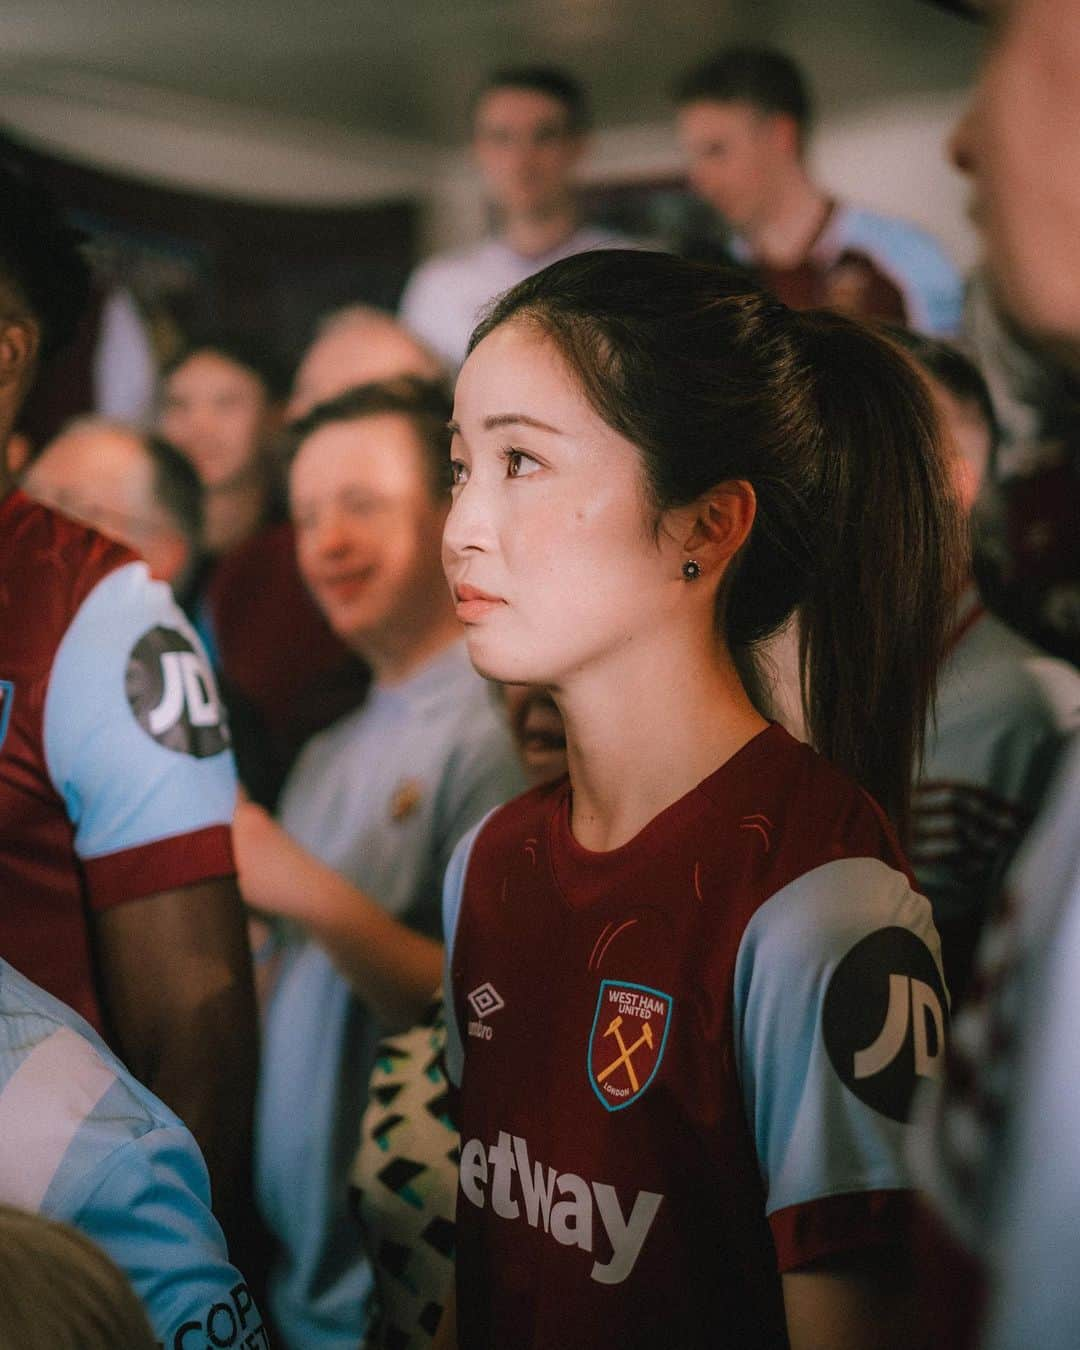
[0,491,236,1030]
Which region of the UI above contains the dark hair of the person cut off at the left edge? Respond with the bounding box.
[0,161,90,360]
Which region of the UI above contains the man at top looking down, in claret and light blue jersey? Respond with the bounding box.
[674,46,963,335]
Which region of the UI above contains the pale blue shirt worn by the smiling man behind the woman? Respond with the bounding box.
[255,643,524,1350]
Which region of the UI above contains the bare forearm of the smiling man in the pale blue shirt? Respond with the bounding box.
[232,802,443,1030]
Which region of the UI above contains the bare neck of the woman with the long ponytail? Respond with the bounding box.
[555,639,768,852]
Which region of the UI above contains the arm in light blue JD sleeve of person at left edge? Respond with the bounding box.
[43,550,258,1263]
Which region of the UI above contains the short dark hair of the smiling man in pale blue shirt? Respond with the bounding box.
[284,375,454,497]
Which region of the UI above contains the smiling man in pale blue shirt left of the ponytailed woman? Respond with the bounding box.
[234,379,522,1350]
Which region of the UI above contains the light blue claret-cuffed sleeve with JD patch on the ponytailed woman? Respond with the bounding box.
[734,857,948,1270]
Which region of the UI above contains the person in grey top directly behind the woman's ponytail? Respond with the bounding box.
[892,331,1080,1008]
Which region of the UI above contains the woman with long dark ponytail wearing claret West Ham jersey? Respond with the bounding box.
[440,251,961,1350]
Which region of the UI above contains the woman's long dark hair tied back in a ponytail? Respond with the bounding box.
[470,250,961,832]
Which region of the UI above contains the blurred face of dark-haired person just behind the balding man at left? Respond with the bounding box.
[161,351,273,489]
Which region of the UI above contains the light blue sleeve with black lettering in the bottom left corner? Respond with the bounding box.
[69,1125,269,1350]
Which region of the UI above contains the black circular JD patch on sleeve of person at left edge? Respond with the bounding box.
[124,628,228,759]
